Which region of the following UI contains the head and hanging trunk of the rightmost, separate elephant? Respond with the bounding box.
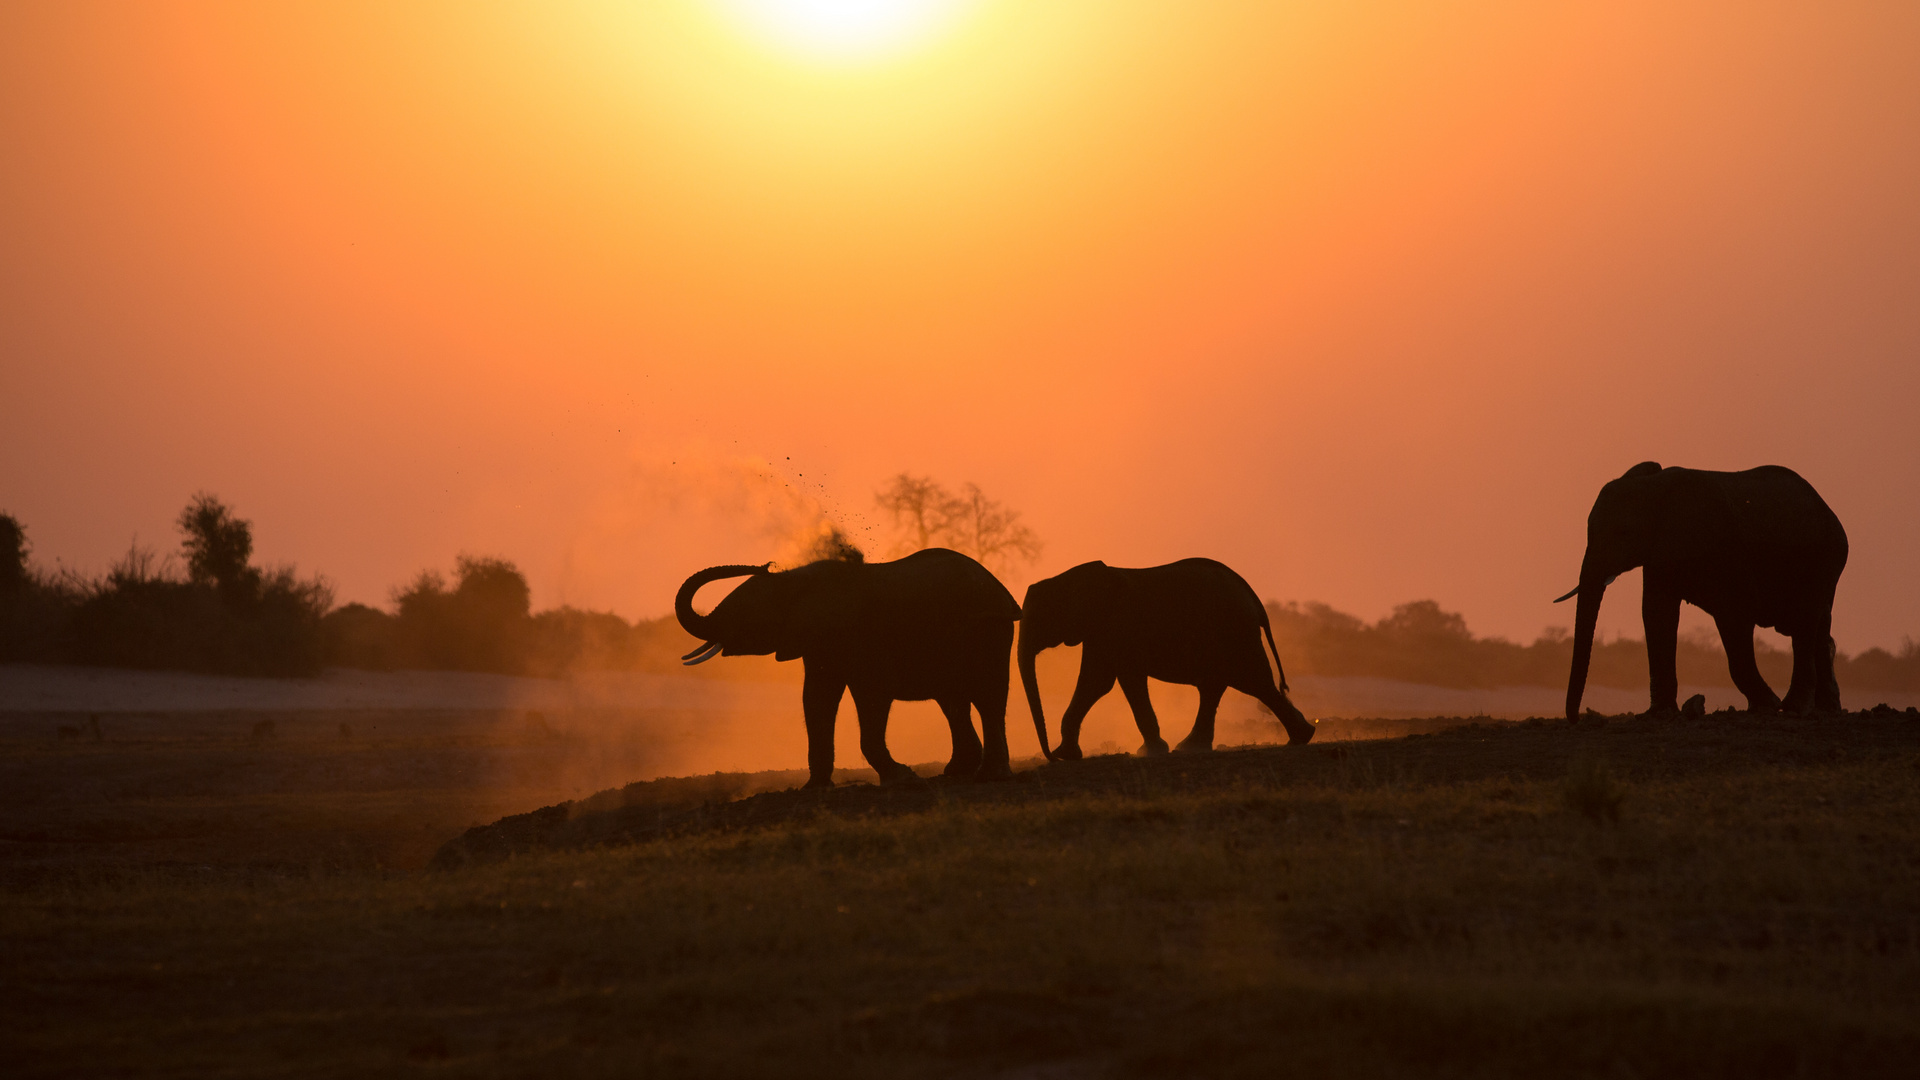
[1553,461,1726,719]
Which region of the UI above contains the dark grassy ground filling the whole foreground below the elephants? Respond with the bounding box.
[0,713,1920,1078]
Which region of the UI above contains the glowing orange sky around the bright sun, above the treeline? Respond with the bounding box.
[0,0,1920,650]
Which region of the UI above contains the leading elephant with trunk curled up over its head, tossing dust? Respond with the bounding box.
[674,548,1020,788]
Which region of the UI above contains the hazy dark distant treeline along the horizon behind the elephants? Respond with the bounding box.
[0,496,1920,692]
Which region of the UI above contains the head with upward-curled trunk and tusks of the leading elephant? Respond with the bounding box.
[674,563,845,665]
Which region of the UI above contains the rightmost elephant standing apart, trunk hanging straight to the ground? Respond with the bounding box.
[1555,461,1847,719]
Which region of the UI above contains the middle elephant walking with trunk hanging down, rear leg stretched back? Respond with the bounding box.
[1018,559,1313,761]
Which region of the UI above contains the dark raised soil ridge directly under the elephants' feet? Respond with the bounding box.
[432,709,1920,869]
